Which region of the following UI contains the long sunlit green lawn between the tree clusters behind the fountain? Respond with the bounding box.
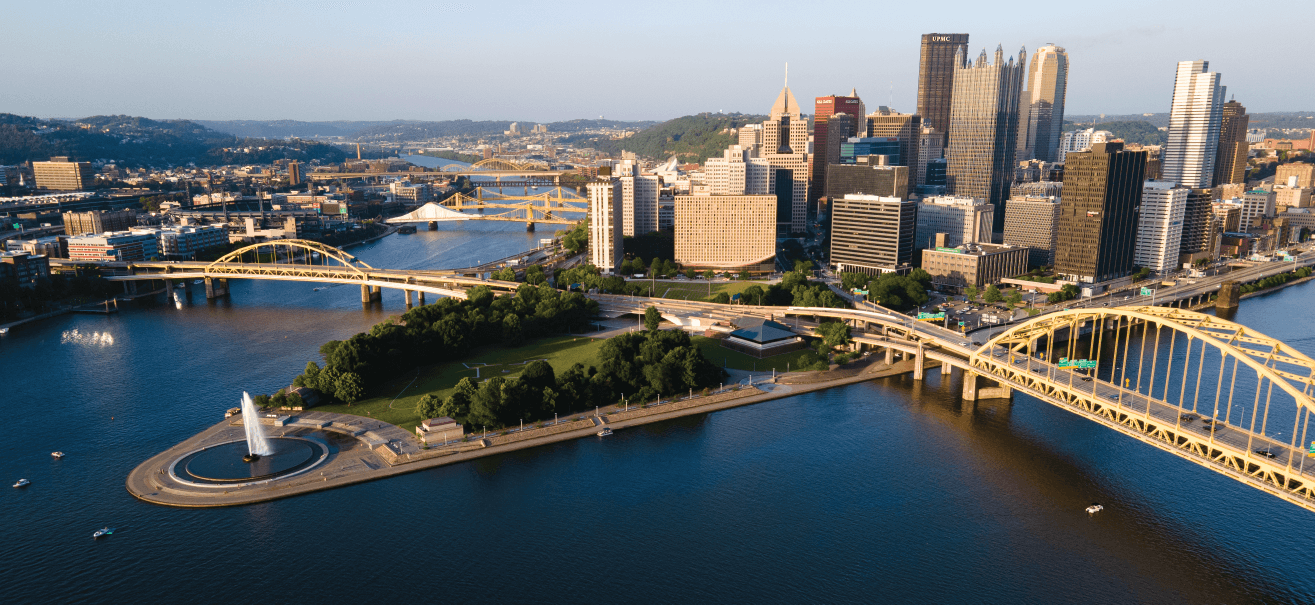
[316,337,604,431]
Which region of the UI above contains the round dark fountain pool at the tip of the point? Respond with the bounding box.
[172,437,327,485]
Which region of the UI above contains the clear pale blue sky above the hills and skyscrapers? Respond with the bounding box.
[0,0,1315,122]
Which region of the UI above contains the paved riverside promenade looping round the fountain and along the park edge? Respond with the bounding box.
[125,360,939,508]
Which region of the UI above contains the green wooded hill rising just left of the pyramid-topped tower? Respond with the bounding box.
[569,113,767,163]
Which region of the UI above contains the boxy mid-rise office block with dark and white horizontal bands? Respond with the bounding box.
[830,193,918,275]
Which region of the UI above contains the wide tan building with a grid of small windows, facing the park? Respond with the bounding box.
[675,195,776,274]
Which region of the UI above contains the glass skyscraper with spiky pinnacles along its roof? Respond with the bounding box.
[945,46,1026,231]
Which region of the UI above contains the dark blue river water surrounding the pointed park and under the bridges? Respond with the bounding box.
[0,178,1315,604]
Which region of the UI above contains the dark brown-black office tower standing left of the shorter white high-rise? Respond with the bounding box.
[1055,142,1147,283]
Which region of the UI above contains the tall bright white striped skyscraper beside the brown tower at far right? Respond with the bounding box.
[1160,61,1224,188]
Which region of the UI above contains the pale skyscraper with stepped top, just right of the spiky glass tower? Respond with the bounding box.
[1018,45,1068,162]
